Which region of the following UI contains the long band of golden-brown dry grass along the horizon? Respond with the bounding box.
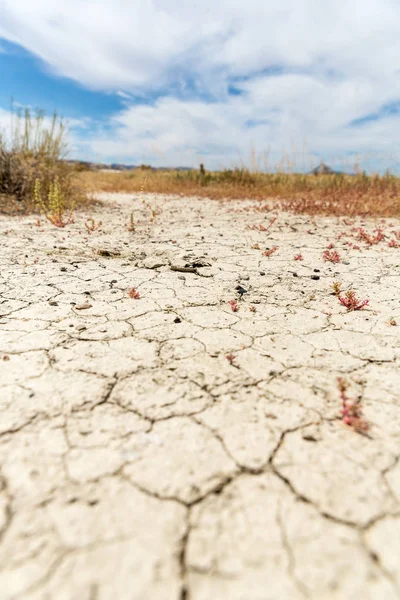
[76,168,400,217]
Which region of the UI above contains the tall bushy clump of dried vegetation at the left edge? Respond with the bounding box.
[0,107,88,216]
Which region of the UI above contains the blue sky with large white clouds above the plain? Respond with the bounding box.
[0,0,400,170]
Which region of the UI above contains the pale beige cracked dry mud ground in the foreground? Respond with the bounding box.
[0,195,400,600]
